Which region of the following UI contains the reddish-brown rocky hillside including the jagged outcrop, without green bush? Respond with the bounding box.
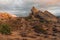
[0,7,60,40]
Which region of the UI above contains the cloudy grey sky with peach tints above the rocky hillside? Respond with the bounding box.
[0,0,60,16]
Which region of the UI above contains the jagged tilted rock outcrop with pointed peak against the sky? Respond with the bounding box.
[31,7,58,22]
